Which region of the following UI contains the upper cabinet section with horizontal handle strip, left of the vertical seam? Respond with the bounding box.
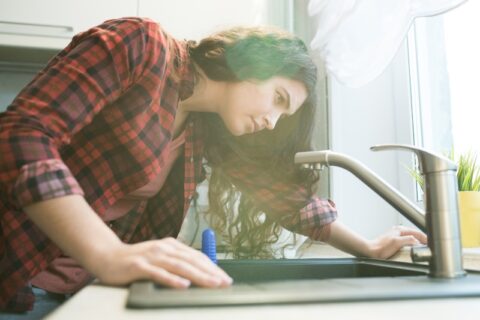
[0,0,138,49]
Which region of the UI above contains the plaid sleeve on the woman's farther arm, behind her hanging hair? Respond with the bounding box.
[222,162,337,241]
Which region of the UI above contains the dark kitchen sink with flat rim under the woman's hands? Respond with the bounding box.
[127,258,480,308]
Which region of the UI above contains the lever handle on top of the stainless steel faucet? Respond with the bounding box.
[370,144,457,174]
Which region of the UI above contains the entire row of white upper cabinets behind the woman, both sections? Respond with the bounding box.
[0,0,292,51]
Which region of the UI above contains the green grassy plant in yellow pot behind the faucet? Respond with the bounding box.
[410,152,480,247]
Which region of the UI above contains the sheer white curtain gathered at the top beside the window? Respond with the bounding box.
[308,0,466,87]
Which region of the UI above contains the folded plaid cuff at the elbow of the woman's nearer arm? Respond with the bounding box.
[13,159,84,208]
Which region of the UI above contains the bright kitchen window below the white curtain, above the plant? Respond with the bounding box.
[408,1,480,160]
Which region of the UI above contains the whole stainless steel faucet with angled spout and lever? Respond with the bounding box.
[295,144,466,278]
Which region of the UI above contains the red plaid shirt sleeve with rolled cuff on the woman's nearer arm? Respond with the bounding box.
[0,18,161,208]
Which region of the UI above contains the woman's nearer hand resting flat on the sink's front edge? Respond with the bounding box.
[95,238,232,288]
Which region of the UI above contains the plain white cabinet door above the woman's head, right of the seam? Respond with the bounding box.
[138,0,274,40]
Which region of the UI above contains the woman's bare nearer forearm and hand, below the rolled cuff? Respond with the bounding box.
[24,195,231,288]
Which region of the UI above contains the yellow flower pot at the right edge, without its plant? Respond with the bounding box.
[458,191,480,248]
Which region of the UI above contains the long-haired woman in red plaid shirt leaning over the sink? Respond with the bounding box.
[0,18,425,311]
